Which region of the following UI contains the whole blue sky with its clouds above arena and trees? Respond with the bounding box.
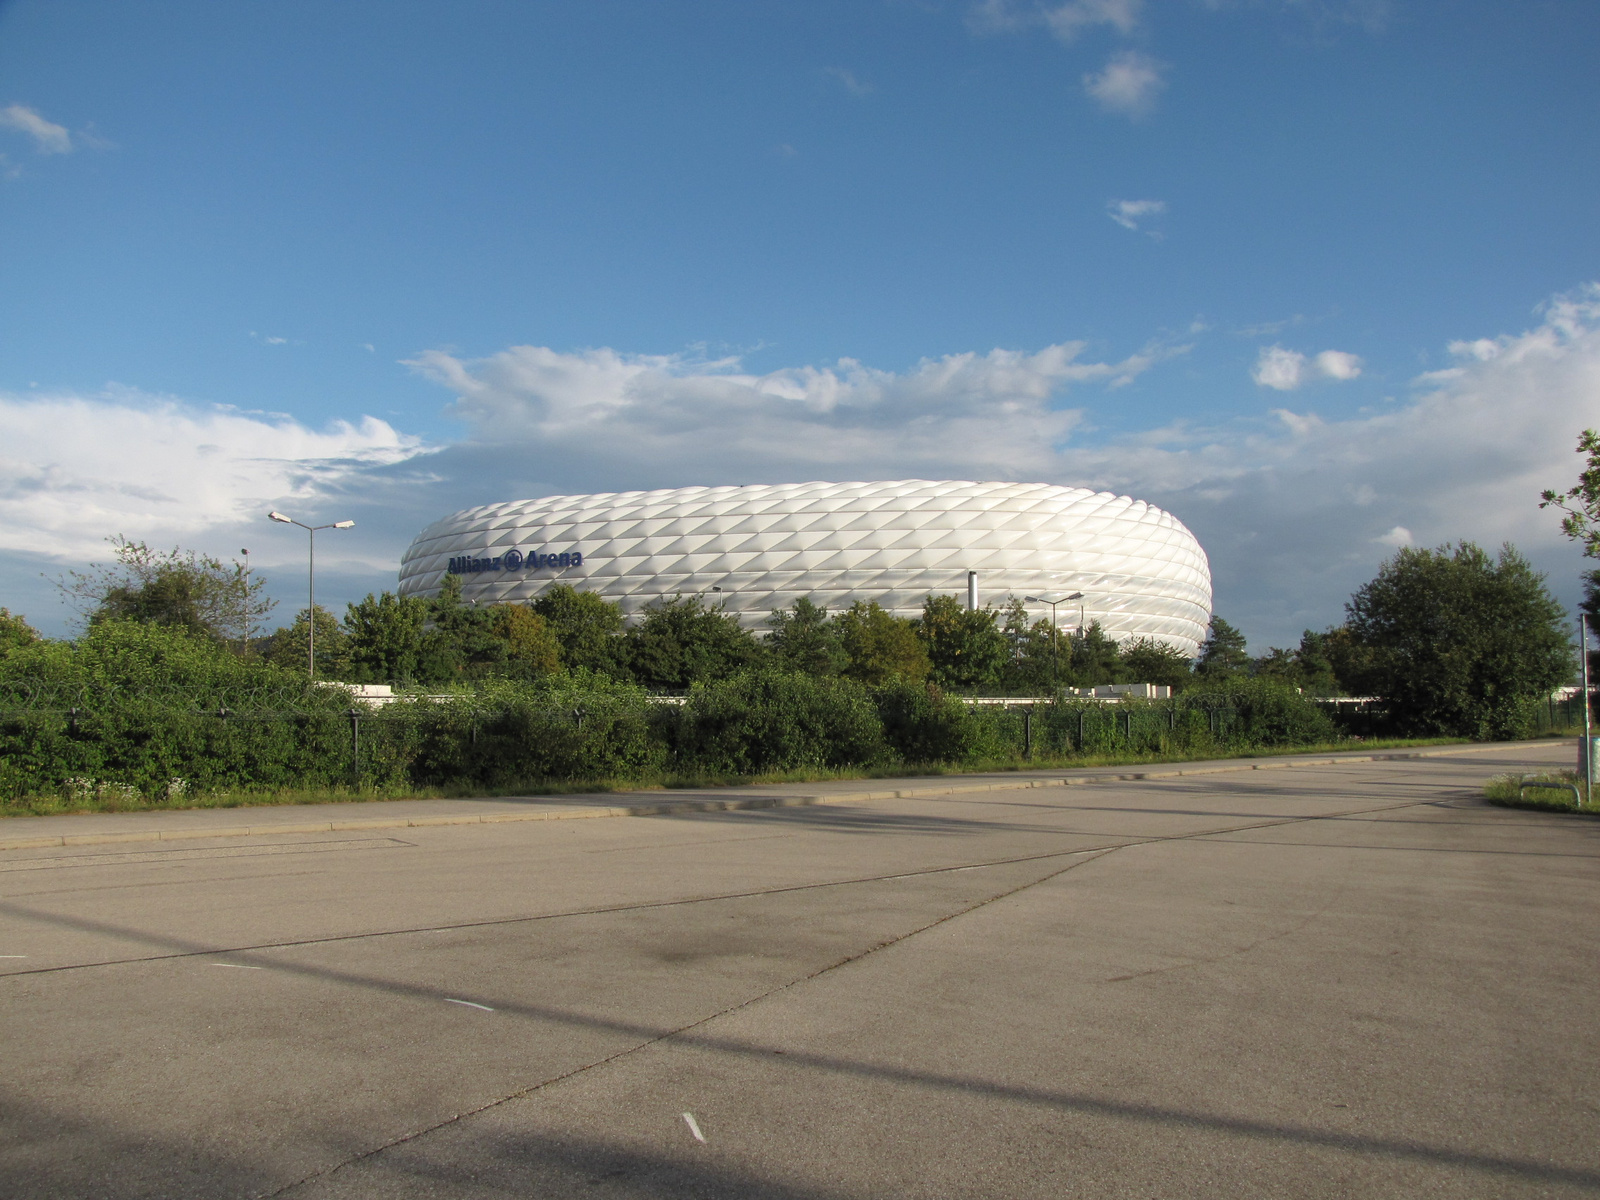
[0,0,1600,650]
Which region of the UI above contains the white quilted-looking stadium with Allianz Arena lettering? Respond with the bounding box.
[400,480,1211,654]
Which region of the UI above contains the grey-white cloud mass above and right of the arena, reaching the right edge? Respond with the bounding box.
[411,286,1600,648]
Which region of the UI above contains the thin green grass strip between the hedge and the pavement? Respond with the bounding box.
[0,738,1523,818]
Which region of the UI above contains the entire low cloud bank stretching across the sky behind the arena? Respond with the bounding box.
[0,285,1600,651]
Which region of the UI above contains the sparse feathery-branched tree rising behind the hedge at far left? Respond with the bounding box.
[56,534,277,651]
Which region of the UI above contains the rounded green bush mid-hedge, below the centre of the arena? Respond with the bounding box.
[669,669,885,774]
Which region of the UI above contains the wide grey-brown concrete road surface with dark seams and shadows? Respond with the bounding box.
[0,749,1600,1200]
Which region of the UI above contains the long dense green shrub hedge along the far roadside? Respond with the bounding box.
[0,622,1369,803]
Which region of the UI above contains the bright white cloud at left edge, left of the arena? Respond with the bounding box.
[0,390,424,557]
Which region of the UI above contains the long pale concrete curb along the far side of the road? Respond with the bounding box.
[0,741,1565,850]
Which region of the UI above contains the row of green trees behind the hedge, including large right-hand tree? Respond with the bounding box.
[0,512,1574,738]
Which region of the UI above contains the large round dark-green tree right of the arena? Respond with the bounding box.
[1346,542,1573,739]
